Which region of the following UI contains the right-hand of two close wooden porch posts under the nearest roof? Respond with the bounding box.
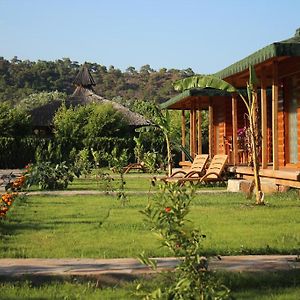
[272,61,279,170]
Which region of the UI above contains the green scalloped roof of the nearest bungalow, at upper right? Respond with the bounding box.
[214,28,300,79]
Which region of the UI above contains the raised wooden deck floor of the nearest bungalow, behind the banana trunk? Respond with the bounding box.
[235,166,300,188]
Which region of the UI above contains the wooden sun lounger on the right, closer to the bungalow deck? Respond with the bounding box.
[178,154,228,185]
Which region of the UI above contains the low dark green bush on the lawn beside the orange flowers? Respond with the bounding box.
[26,162,73,190]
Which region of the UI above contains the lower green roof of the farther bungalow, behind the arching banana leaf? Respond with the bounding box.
[160,88,231,109]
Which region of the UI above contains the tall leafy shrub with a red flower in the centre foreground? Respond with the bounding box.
[138,183,229,299]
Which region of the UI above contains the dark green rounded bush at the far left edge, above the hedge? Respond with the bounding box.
[0,103,31,137]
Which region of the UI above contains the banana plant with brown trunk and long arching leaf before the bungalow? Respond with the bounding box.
[173,66,264,205]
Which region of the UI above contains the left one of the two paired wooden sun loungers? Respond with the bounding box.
[161,154,208,182]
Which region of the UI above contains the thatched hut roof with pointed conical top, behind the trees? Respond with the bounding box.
[30,65,151,131]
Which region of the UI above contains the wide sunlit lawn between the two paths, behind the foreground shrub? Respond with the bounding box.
[0,192,300,258]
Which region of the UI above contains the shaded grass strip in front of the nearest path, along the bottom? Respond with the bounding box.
[0,270,300,300]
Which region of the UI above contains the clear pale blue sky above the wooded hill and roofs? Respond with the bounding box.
[0,0,300,73]
